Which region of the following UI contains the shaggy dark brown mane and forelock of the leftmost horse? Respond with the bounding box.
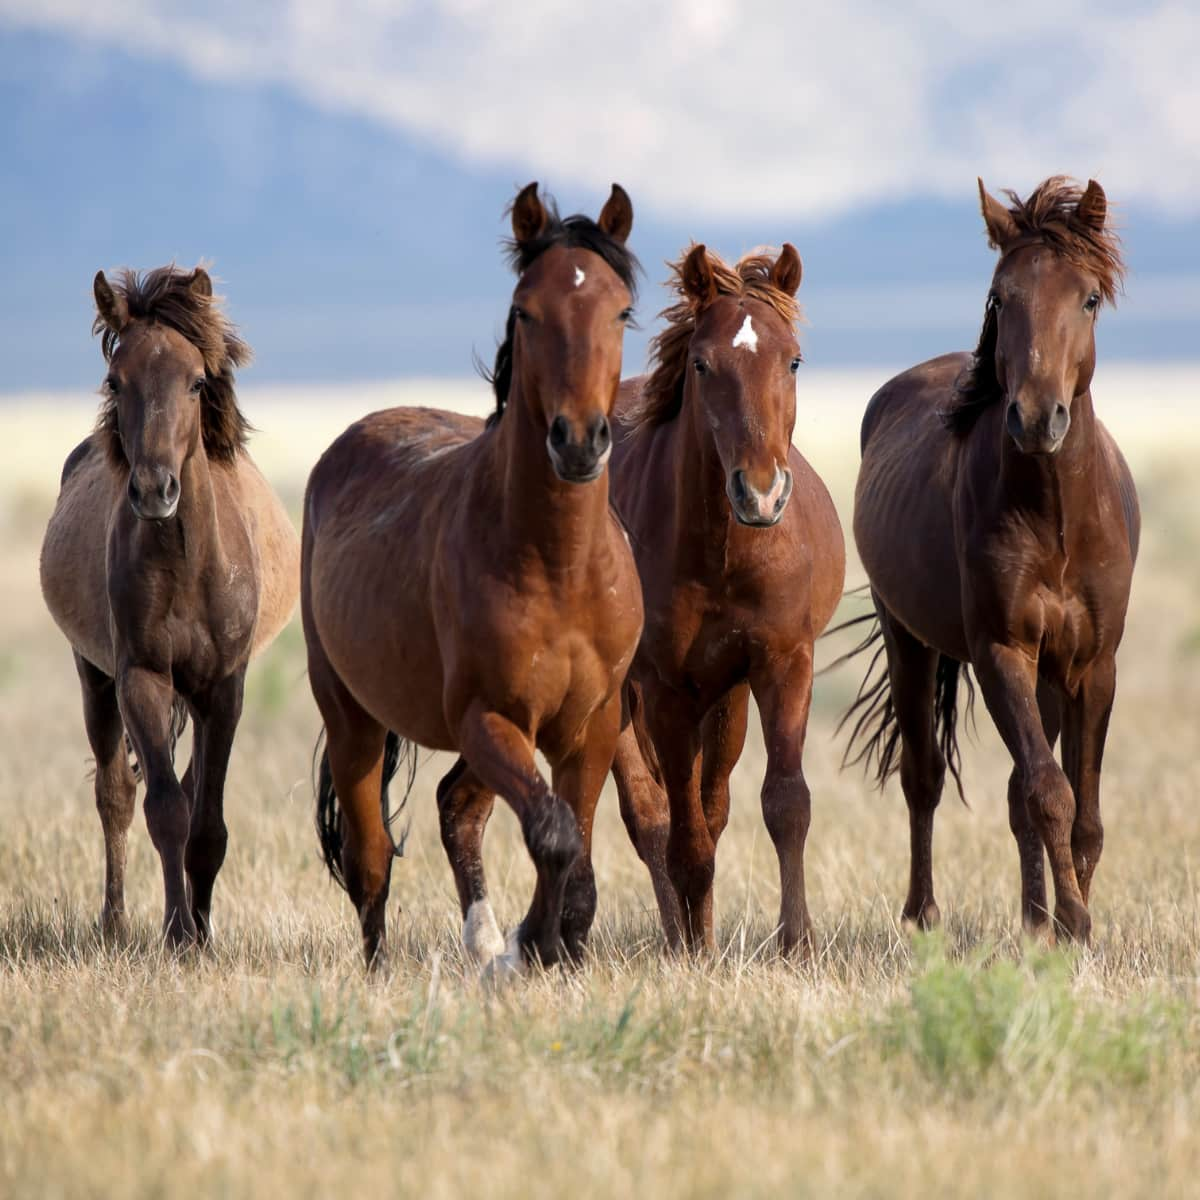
[91,263,251,463]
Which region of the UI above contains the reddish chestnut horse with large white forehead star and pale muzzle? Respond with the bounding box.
[612,245,846,950]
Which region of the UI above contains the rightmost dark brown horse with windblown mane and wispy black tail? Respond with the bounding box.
[847,176,1140,941]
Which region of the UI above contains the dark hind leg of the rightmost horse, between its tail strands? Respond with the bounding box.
[876,600,946,929]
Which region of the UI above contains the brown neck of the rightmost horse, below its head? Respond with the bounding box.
[1000,389,1098,547]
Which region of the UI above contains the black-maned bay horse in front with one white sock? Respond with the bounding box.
[301,184,642,970]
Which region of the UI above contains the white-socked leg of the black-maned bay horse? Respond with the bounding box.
[438,758,505,964]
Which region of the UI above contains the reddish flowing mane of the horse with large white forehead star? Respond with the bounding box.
[624,242,800,428]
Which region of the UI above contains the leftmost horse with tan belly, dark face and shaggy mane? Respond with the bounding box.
[42,266,299,946]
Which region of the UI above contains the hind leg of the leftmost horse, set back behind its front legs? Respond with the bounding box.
[74,654,137,942]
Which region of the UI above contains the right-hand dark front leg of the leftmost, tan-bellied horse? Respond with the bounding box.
[184,667,246,942]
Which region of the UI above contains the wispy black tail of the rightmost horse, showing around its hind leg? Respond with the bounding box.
[832,614,974,804]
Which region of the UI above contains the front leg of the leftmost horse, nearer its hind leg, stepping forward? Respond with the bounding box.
[116,666,196,948]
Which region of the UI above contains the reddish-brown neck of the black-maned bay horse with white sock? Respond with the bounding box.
[487,380,608,572]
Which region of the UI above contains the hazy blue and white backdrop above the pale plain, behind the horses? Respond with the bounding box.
[0,0,1200,390]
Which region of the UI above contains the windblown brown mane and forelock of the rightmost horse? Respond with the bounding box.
[942,175,1124,434]
